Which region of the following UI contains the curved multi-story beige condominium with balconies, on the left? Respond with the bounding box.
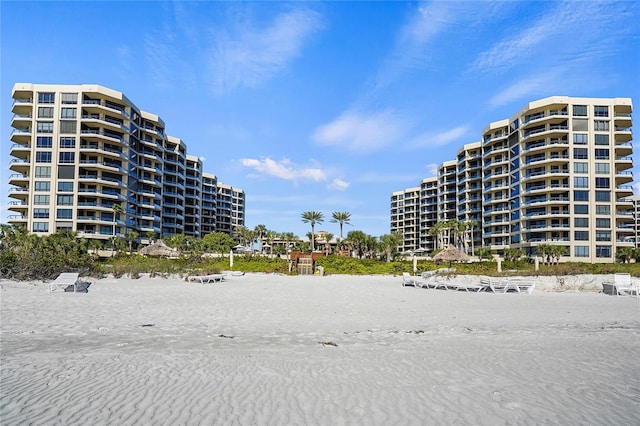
[8,83,245,243]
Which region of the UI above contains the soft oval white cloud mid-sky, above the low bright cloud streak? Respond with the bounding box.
[312,111,409,154]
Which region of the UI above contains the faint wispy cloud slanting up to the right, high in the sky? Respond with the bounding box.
[208,7,323,94]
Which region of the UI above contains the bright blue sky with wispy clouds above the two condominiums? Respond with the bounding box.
[0,1,640,236]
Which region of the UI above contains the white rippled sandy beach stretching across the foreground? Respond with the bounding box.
[0,274,640,425]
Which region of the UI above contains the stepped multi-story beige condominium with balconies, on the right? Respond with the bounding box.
[391,96,637,263]
